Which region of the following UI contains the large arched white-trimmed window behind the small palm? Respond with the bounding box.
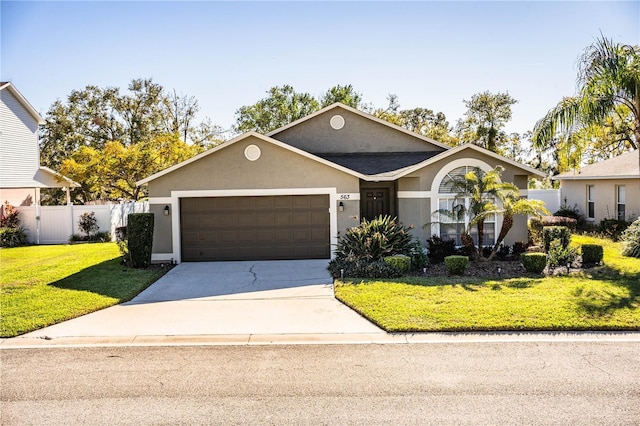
[438,166,497,246]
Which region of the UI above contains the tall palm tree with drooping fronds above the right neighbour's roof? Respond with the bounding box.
[533,36,640,162]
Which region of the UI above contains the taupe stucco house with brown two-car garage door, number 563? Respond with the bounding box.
[138,104,544,262]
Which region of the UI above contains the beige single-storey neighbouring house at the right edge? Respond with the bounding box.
[553,150,640,224]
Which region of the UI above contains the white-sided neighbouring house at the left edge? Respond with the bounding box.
[0,82,80,206]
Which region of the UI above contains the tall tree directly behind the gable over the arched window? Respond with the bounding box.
[457,91,518,152]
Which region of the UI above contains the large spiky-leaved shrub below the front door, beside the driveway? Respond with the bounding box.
[336,216,413,263]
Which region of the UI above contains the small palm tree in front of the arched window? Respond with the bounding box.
[437,166,514,261]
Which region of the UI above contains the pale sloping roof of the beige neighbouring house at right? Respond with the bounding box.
[552,150,640,180]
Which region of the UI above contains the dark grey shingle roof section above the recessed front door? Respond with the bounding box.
[314,151,440,175]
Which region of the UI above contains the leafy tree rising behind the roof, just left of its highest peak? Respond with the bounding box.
[234,85,320,133]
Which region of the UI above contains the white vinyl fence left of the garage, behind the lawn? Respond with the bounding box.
[17,201,149,244]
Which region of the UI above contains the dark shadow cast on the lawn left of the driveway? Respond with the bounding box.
[49,258,165,303]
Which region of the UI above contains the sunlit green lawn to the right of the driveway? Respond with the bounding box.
[335,235,640,332]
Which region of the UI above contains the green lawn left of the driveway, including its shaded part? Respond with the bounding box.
[0,243,164,337]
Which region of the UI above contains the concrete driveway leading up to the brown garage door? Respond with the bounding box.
[22,260,384,341]
